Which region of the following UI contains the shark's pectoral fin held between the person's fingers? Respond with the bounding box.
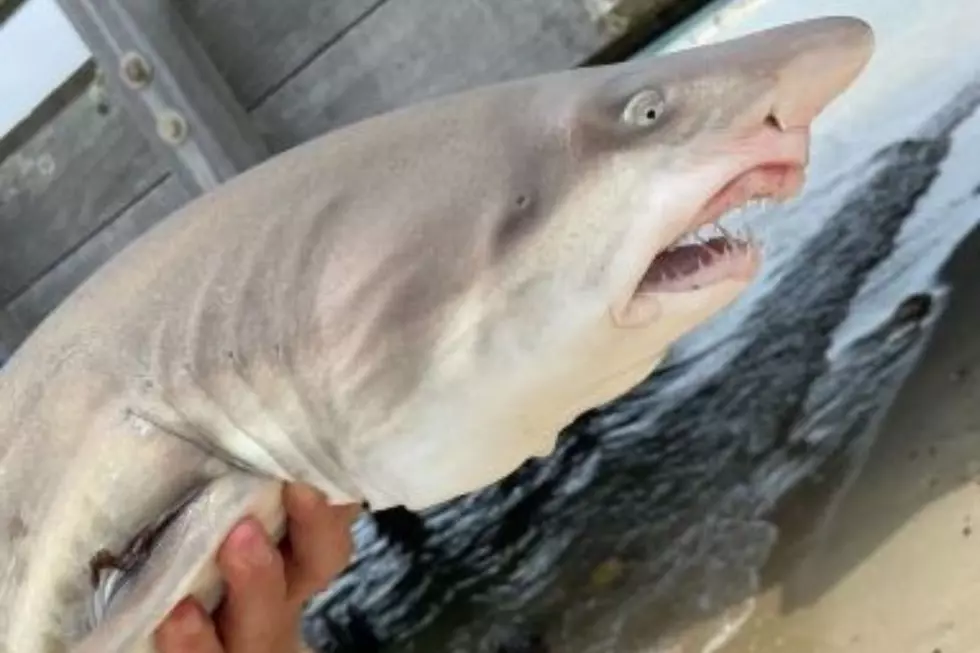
[72,472,285,653]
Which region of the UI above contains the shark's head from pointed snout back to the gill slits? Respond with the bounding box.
[290,18,873,508]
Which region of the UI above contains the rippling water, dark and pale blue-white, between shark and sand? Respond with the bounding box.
[306,0,980,653]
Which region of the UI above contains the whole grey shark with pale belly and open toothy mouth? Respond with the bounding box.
[0,17,873,653]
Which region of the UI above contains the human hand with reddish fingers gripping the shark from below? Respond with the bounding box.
[155,484,360,653]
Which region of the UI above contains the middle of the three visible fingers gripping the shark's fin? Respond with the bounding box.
[216,519,294,653]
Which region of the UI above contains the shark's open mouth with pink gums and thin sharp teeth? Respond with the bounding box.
[637,163,803,294]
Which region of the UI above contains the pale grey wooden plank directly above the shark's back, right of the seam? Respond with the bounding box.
[249,0,610,150]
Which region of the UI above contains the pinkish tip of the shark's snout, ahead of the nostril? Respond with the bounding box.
[769,17,874,130]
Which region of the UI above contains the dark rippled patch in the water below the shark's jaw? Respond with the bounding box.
[306,83,980,653]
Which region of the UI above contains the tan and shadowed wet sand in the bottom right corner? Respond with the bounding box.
[712,222,980,653]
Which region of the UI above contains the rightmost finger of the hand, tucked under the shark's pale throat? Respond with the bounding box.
[283,483,360,604]
